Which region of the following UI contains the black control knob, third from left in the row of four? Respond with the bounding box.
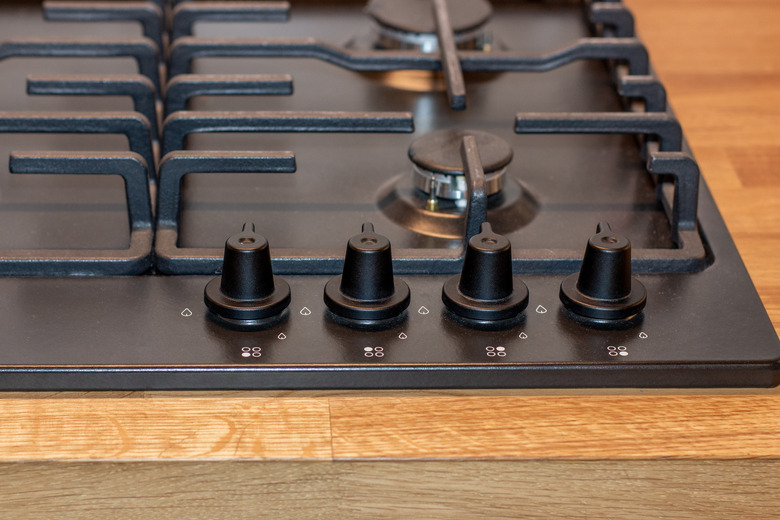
[441,222,528,321]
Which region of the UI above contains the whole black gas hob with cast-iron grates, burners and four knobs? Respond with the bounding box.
[0,0,780,390]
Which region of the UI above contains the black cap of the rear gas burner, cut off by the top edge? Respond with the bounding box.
[366,0,492,33]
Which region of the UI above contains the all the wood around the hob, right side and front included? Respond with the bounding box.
[0,0,780,519]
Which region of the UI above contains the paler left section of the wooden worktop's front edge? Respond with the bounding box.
[0,398,331,461]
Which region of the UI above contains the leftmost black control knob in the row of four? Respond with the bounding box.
[204,223,290,325]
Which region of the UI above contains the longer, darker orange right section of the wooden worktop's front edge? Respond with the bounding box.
[331,396,780,460]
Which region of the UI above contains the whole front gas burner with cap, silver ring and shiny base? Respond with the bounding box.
[378,129,538,239]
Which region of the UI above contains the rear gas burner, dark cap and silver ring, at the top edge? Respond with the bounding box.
[366,0,493,52]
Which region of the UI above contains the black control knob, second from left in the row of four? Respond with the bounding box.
[324,223,410,321]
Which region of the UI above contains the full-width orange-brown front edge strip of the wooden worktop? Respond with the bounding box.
[0,393,780,463]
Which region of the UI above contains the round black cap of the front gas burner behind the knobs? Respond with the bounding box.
[409,128,512,175]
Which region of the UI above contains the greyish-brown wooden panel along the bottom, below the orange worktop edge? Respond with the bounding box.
[0,461,780,520]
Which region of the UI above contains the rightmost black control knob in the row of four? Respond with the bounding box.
[560,222,647,320]
